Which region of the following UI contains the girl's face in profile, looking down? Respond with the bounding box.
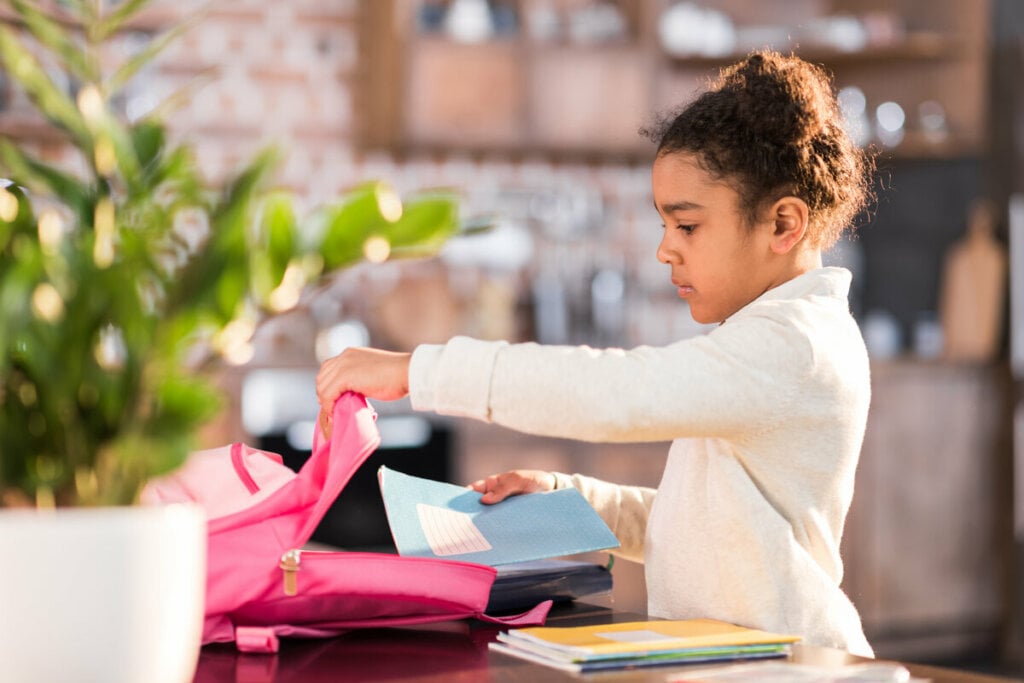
[651,153,779,324]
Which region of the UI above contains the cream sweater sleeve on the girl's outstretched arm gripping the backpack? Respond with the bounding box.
[409,321,807,442]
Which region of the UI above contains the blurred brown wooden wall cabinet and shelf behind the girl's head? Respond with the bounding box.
[358,0,988,159]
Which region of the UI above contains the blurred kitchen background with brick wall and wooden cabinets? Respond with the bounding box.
[8,0,1024,673]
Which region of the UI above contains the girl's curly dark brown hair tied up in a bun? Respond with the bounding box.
[641,50,873,249]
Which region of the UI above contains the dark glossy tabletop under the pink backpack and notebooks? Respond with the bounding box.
[195,602,1013,683]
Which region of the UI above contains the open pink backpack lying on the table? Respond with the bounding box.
[142,393,551,652]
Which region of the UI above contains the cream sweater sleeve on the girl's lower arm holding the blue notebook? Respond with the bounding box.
[554,472,654,562]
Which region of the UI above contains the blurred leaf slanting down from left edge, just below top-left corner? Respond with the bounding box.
[0,25,92,147]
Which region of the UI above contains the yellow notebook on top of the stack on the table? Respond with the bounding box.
[500,618,800,659]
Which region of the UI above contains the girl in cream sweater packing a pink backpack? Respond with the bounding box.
[317,51,871,655]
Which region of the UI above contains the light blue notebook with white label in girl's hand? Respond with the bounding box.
[377,467,618,566]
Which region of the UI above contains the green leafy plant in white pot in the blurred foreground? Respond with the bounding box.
[0,0,458,683]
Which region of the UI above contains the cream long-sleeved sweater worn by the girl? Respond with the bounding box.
[409,268,871,655]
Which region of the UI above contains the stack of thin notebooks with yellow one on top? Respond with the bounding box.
[489,620,800,672]
